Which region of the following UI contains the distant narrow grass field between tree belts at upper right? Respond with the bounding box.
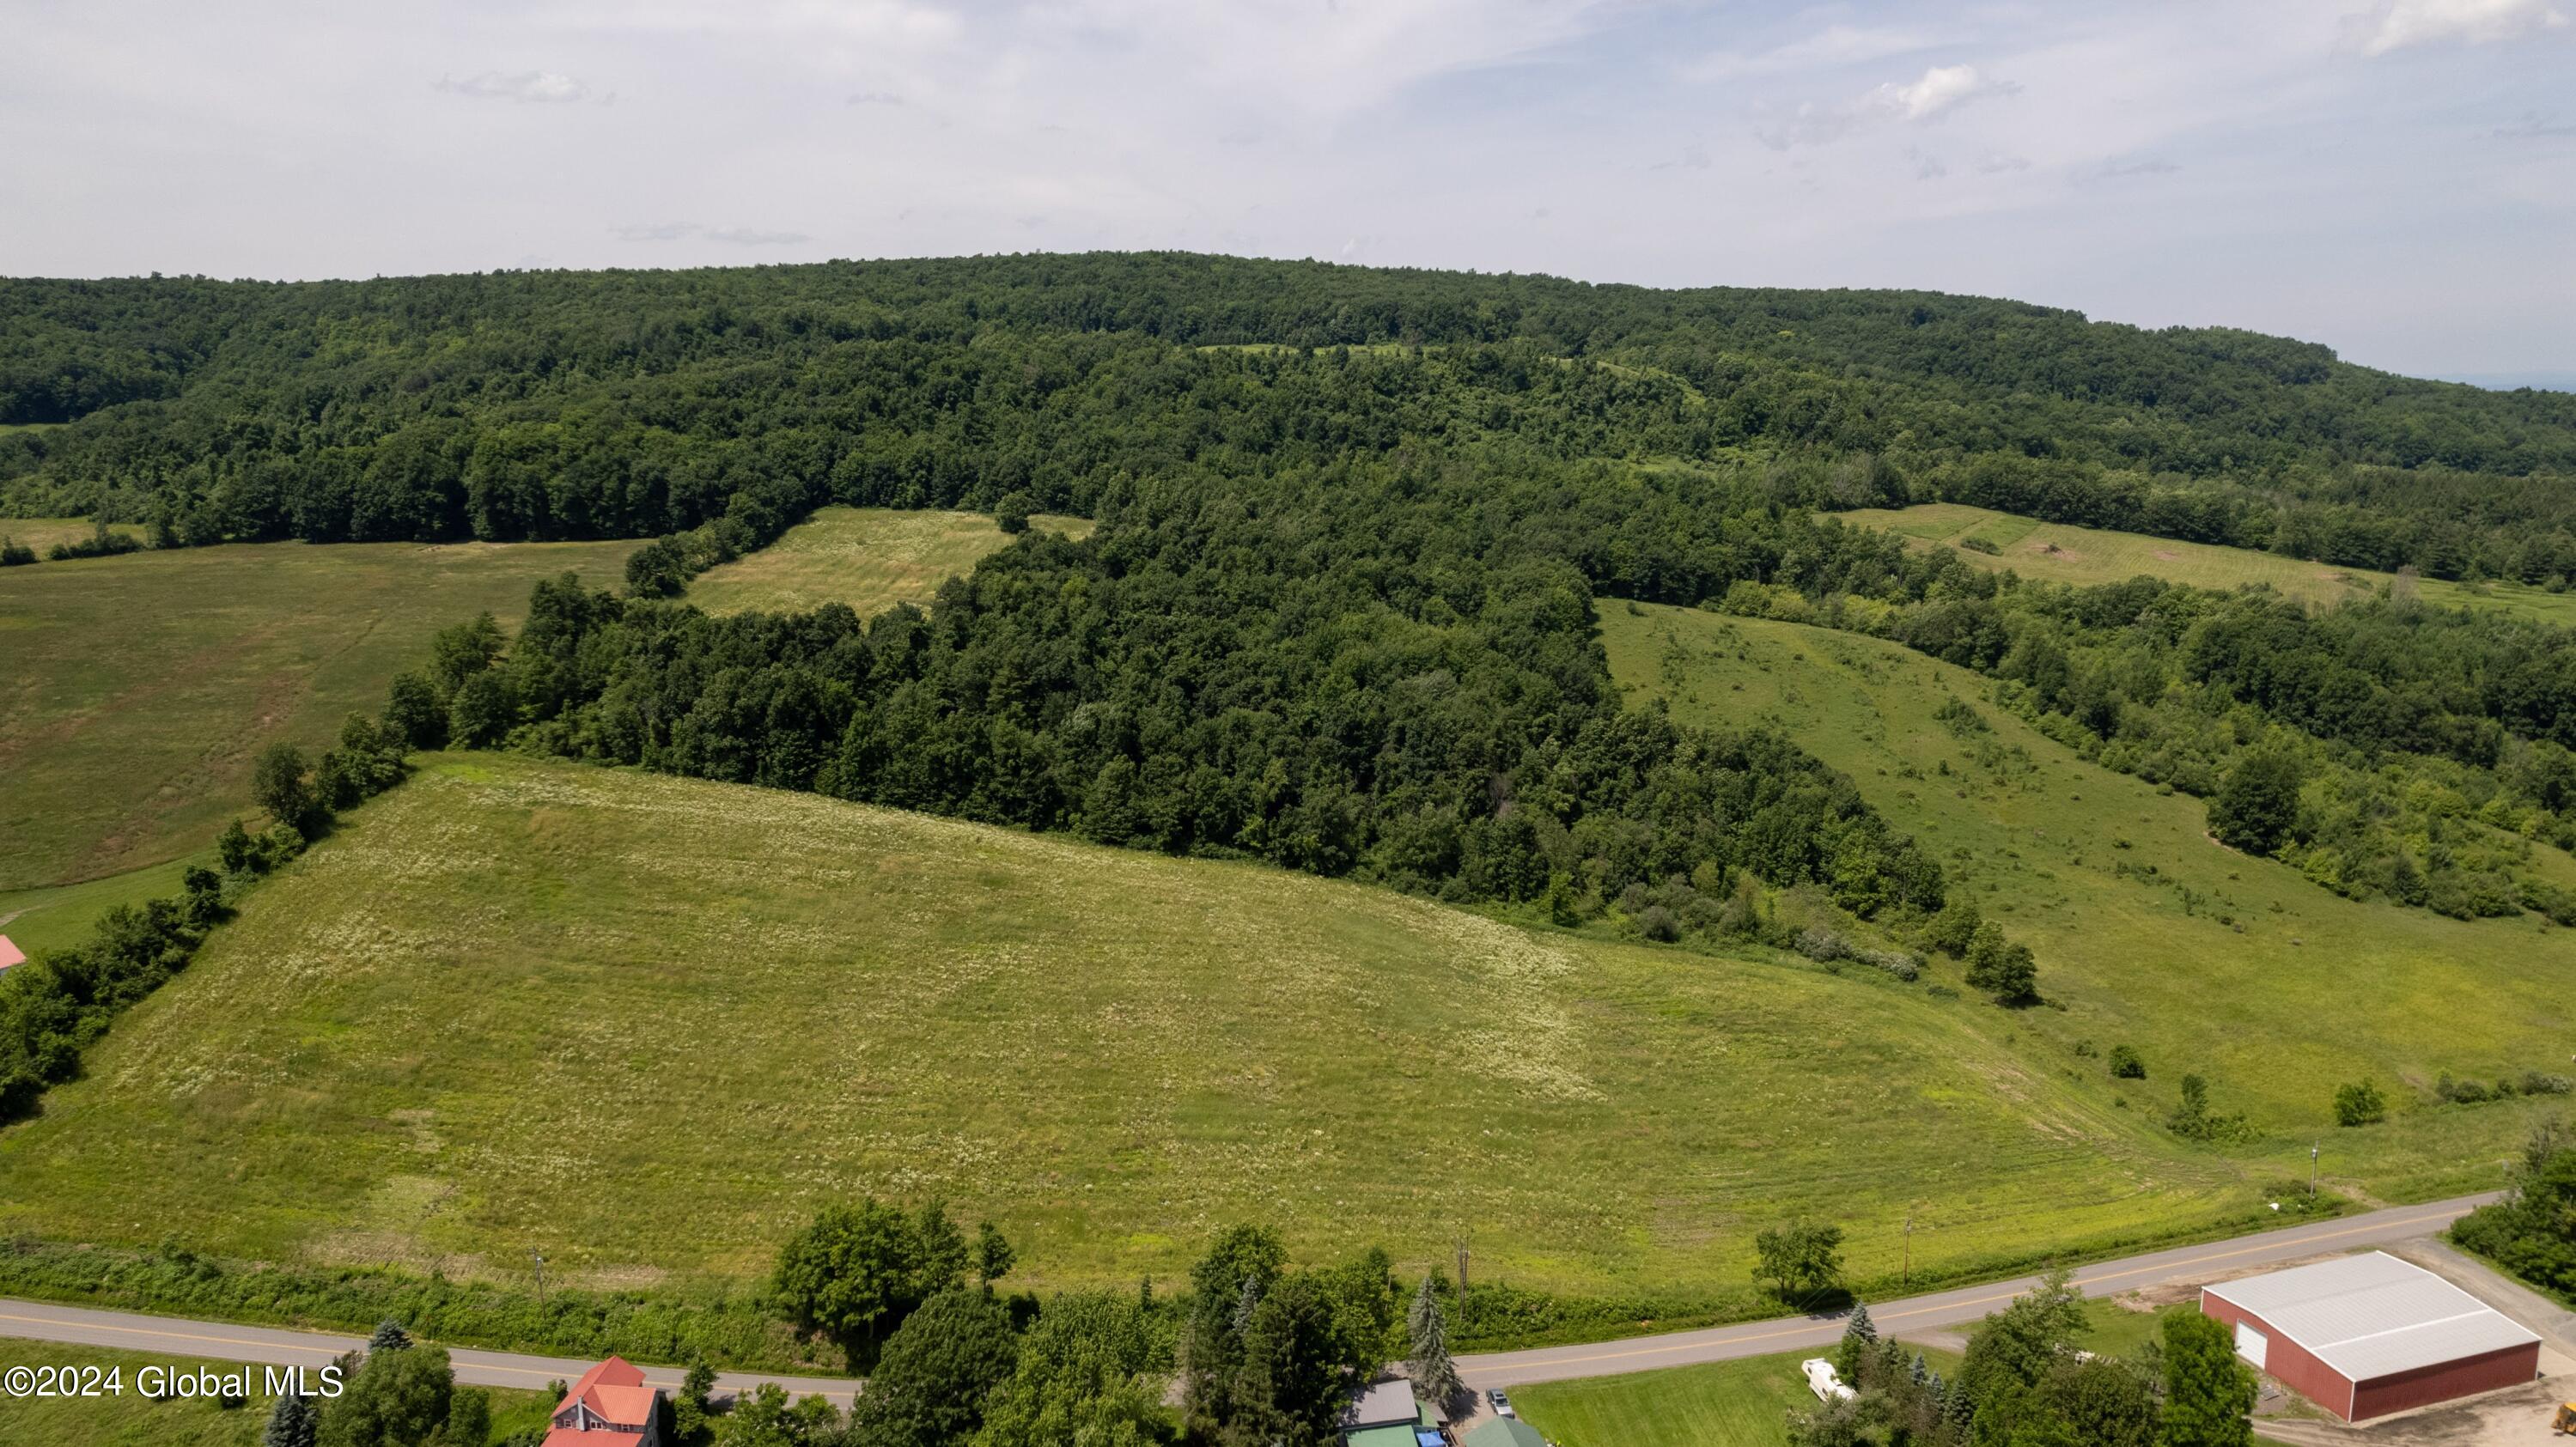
[1834,502,2576,626]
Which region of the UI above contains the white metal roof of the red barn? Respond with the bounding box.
[2205,1251,2540,1383]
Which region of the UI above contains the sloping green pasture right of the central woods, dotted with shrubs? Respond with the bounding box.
[1602,605,2576,1197]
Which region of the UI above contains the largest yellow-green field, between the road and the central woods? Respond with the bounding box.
[0,754,2298,1292]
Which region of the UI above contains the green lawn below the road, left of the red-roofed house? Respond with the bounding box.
[0,1336,554,1447]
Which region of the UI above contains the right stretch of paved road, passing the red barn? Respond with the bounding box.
[1458,1192,2499,1390]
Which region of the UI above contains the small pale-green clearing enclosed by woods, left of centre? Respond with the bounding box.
[688,508,1093,618]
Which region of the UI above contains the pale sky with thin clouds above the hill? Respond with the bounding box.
[0,0,2576,376]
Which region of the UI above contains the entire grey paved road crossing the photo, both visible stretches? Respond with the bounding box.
[0,1192,2496,1406]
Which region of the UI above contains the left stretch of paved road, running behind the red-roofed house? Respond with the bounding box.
[0,1300,858,1406]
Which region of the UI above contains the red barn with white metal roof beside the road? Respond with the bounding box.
[2200,1251,2540,1421]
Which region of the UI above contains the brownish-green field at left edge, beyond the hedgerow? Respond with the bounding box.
[0,532,634,891]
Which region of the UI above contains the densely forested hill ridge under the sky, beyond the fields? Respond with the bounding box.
[15,255,2576,582]
